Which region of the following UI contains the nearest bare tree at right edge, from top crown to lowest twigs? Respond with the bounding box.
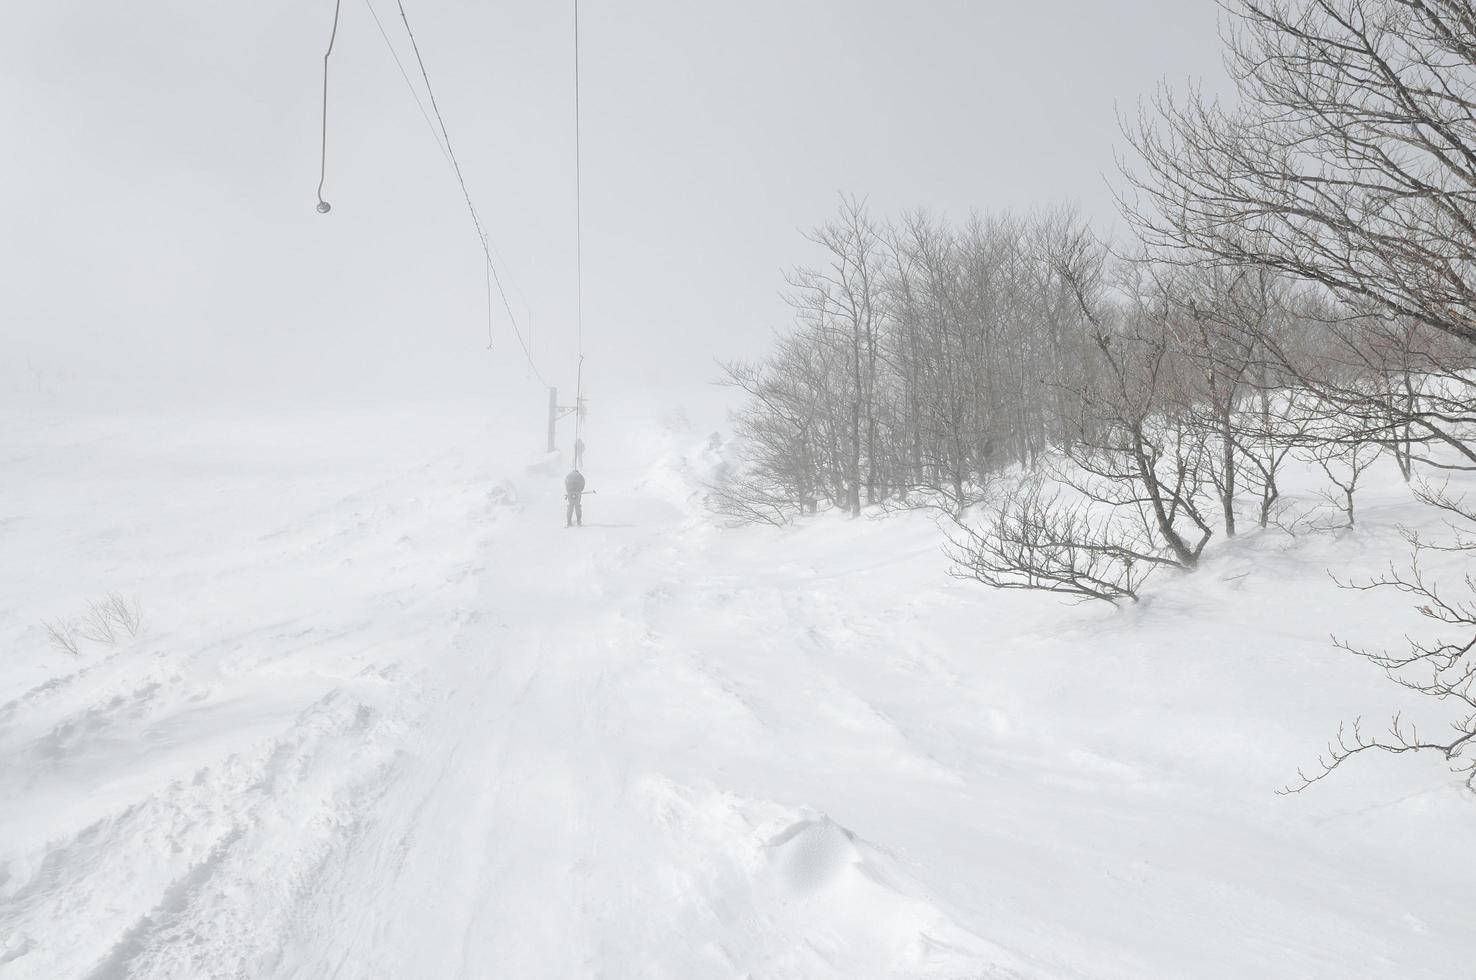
[1122,0,1476,790]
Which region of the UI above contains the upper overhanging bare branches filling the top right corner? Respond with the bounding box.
[1123,0,1476,352]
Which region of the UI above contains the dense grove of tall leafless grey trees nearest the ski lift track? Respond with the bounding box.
[713,199,1091,524]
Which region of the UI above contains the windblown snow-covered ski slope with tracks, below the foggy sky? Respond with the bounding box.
[0,406,1476,980]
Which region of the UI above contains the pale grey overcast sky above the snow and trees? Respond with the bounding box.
[0,0,1221,404]
